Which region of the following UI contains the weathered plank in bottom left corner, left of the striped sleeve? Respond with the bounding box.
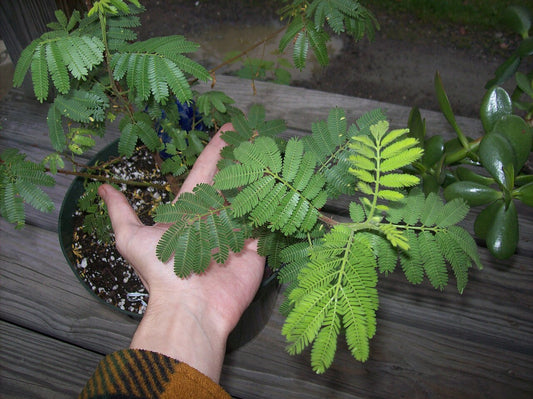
[0,322,102,399]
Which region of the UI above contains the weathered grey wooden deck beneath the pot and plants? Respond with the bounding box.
[0,76,533,399]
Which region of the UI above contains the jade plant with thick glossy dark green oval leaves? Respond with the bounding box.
[409,6,533,259]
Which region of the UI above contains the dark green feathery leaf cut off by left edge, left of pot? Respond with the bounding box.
[0,149,55,227]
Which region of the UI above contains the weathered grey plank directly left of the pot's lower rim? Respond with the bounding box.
[0,220,137,353]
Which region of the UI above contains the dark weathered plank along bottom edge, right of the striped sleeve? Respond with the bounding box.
[221,301,533,399]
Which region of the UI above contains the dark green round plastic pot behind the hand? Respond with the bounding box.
[58,140,280,352]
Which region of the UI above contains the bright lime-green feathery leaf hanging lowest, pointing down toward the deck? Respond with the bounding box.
[282,227,378,373]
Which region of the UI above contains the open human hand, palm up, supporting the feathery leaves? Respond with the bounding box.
[99,124,265,382]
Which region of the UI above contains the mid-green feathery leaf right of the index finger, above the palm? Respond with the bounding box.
[215,137,327,234]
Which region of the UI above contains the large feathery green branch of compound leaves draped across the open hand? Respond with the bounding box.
[156,106,481,373]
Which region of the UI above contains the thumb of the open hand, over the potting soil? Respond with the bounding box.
[98,184,143,240]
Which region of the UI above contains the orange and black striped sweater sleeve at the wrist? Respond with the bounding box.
[79,349,231,399]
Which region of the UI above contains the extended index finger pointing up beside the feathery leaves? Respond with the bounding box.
[179,123,233,194]
